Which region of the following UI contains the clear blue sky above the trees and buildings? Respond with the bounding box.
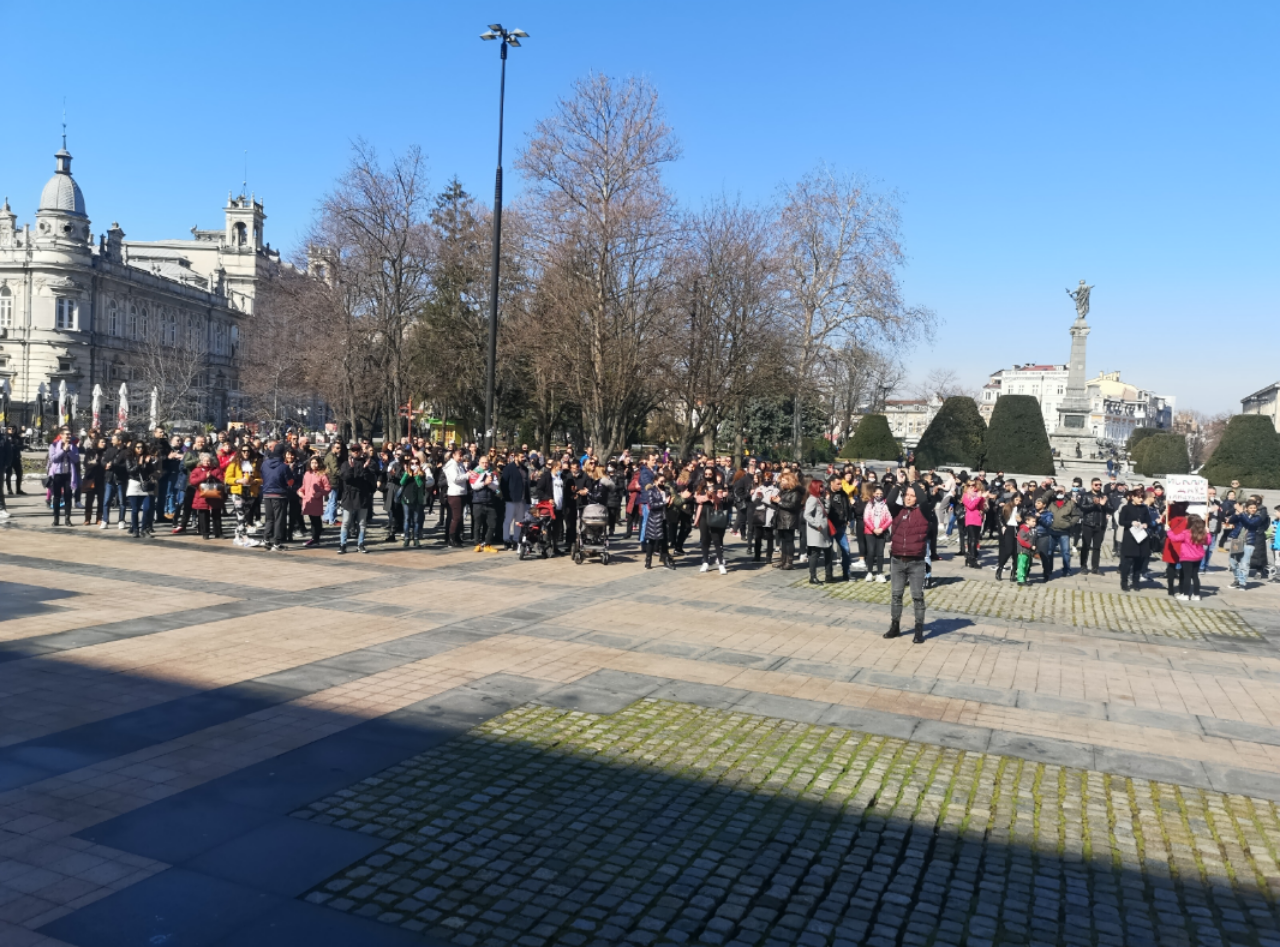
[0,0,1280,411]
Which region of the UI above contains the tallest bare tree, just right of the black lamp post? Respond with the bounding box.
[517,74,680,453]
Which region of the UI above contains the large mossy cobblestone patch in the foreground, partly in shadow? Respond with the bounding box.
[294,699,1280,947]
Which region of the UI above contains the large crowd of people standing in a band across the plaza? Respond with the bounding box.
[0,427,1280,640]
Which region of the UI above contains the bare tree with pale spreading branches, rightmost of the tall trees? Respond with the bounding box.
[781,166,933,459]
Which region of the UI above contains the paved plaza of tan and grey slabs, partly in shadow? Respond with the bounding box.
[0,498,1280,947]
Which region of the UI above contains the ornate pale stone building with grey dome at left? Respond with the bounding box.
[0,142,280,427]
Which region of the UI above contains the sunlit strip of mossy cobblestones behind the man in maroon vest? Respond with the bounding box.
[792,578,1262,641]
